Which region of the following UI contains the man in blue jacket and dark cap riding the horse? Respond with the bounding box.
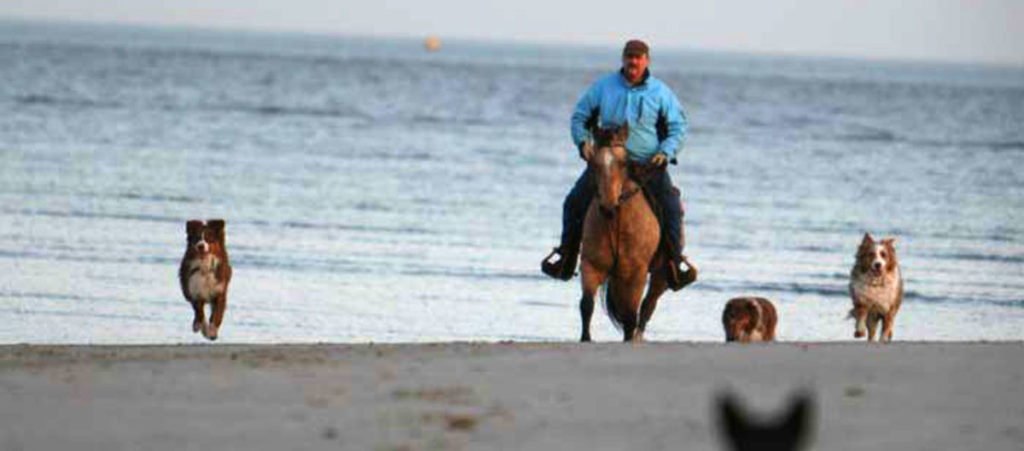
[541,40,696,291]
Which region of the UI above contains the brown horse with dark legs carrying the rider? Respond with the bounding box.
[580,126,688,341]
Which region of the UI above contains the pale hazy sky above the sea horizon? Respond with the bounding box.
[6,0,1024,66]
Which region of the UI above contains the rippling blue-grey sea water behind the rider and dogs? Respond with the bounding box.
[0,23,1024,343]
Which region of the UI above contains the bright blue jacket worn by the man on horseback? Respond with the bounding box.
[572,72,686,163]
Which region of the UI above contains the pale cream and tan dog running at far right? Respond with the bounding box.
[850,234,903,341]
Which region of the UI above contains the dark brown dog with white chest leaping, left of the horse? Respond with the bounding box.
[178,219,231,340]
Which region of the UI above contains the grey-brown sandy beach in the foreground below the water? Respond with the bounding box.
[0,342,1024,450]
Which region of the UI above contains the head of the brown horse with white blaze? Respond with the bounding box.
[588,125,630,217]
